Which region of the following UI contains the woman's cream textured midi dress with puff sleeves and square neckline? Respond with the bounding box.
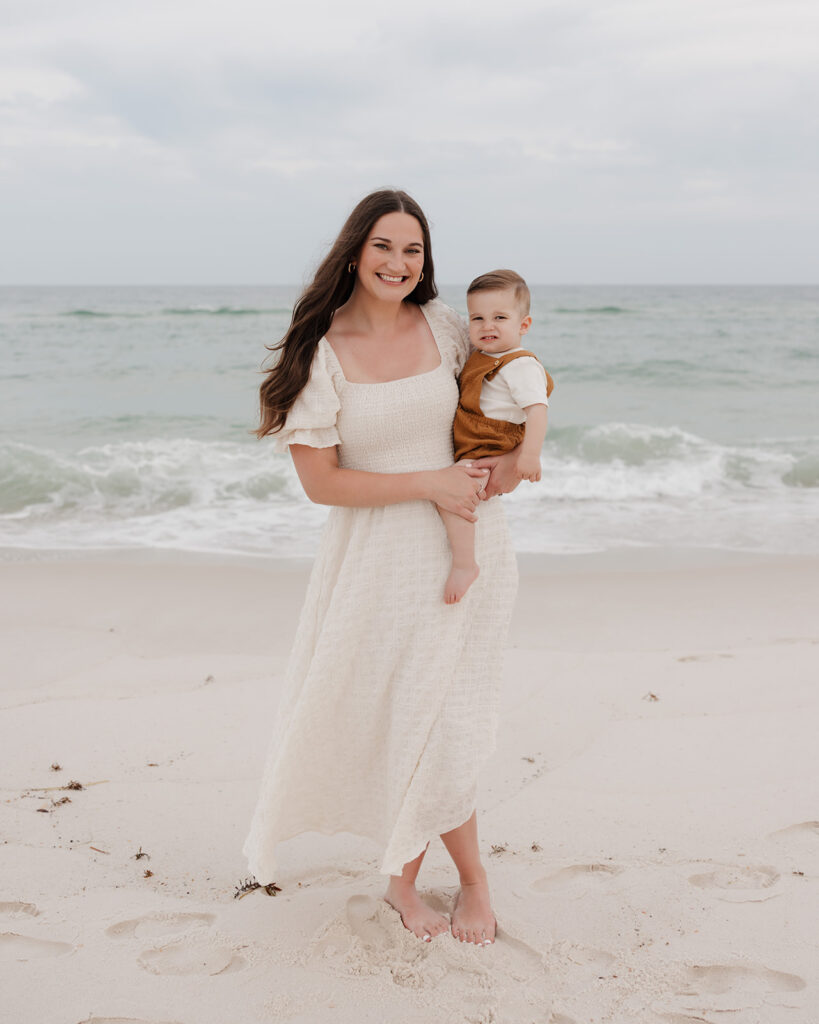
[243,299,518,885]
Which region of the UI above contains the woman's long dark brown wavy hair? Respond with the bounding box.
[254,188,438,437]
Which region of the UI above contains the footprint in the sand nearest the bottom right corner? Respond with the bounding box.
[667,964,806,1020]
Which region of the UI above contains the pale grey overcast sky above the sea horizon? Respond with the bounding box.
[0,0,819,284]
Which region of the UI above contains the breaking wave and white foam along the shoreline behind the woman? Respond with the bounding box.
[0,423,819,555]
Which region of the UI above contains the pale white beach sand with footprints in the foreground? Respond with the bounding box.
[0,553,819,1024]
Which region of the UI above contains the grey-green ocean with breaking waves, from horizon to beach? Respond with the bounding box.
[0,286,819,559]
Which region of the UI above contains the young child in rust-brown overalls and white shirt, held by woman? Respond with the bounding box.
[439,270,554,604]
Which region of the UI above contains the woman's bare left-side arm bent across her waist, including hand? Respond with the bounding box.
[290,444,486,522]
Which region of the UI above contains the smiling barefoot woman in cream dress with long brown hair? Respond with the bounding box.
[244,190,517,944]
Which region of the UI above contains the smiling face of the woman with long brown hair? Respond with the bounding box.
[356,213,424,302]
